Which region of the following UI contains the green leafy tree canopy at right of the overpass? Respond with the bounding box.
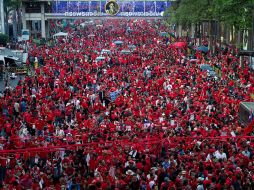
[164,0,254,30]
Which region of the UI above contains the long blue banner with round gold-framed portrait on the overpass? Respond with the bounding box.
[51,0,171,17]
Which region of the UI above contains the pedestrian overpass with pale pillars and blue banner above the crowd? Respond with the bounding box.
[22,0,175,38]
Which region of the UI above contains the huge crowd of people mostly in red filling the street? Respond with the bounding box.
[0,19,254,190]
